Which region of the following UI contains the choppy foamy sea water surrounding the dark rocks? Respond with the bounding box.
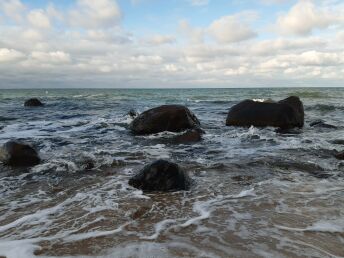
[0,88,344,258]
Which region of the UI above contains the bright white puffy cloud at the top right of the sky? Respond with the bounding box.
[277,0,336,36]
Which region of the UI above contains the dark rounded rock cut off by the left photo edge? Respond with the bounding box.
[0,141,41,167]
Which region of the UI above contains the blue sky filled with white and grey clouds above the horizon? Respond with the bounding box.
[0,0,344,88]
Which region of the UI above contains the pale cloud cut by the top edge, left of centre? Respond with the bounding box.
[70,0,122,29]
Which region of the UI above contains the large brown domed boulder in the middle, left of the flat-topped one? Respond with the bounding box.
[130,105,200,135]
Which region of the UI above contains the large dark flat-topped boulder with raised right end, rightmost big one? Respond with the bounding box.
[226,96,304,129]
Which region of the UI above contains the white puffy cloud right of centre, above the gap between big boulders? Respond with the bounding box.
[207,16,257,44]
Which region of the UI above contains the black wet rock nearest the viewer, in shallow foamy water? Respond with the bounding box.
[129,160,191,192]
